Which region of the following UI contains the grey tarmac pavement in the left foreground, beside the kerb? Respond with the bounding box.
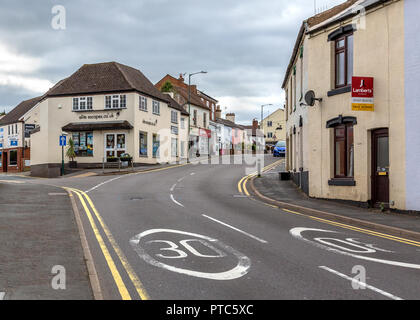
[0,182,93,300]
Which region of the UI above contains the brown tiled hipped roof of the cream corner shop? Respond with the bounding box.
[46,62,168,102]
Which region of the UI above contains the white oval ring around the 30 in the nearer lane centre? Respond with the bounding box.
[130,229,251,280]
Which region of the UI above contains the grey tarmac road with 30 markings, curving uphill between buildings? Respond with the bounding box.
[2,156,420,300]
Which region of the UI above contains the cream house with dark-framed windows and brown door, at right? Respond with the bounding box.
[283,0,420,210]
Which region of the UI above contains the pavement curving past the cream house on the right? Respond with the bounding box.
[251,158,420,240]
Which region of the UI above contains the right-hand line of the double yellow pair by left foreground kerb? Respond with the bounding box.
[80,191,150,300]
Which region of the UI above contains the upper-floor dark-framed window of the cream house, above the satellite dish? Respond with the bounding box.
[334,34,353,88]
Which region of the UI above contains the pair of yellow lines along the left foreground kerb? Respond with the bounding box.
[65,188,149,300]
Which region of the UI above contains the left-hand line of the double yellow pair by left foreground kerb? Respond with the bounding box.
[65,188,131,300]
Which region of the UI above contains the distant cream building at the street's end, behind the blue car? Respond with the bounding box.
[260,108,286,145]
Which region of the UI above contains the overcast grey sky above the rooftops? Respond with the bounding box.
[0,0,344,123]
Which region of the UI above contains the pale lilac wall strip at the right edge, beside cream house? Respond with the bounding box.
[404,0,420,210]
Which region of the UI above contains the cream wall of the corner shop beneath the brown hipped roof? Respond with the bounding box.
[29,92,188,177]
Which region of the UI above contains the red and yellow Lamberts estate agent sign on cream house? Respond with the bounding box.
[351,77,374,111]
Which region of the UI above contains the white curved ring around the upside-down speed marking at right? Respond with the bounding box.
[289,228,420,269]
